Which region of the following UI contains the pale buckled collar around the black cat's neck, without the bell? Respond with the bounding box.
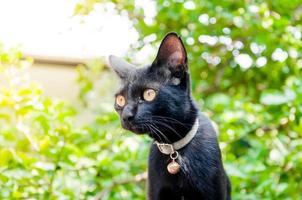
[154,118,199,155]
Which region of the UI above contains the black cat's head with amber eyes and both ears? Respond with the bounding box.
[109,33,197,142]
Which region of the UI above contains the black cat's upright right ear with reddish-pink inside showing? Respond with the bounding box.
[153,32,187,72]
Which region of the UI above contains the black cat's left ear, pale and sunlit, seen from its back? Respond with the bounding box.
[109,55,135,79]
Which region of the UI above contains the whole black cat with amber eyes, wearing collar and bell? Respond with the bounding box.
[109,33,231,200]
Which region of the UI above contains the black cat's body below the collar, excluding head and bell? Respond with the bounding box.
[148,114,230,200]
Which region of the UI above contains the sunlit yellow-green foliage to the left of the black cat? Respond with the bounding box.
[0,49,147,199]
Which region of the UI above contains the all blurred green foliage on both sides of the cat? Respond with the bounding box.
[0,0,302,199]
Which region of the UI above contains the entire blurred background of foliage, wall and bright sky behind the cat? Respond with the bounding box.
[0,0,302,200]
